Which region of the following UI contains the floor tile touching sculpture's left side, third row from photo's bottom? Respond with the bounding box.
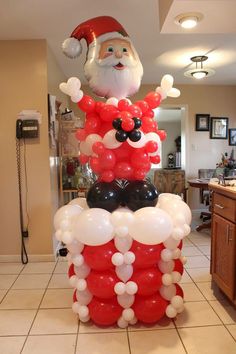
[40,289,74,309]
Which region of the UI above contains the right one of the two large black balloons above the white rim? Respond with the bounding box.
[122,181,159,211]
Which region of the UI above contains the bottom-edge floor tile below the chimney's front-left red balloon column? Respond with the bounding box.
[76,332,129,354]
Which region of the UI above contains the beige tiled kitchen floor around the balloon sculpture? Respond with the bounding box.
[0,214,236,354]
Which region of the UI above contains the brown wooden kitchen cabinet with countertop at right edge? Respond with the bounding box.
[209,184,236,304]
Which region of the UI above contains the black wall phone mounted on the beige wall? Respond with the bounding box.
[16,119,39,139]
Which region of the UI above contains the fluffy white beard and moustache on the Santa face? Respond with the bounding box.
[84,48,143,99]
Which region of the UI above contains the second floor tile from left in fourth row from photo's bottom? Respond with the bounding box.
[12,274,51,289]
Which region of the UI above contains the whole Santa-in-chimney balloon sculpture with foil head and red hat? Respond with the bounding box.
[54,16,191,328]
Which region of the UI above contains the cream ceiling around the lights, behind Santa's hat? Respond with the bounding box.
[0,0,236,85]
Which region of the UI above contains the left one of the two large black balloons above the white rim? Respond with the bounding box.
[87,182,122,212]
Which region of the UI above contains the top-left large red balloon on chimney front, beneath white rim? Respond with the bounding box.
[83,241,117,271]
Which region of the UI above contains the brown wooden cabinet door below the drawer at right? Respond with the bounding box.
[212,214,236,300]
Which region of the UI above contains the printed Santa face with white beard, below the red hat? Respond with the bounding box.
[84,38,143,99]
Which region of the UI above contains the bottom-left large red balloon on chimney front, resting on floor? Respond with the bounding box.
[88,297,123,326]
